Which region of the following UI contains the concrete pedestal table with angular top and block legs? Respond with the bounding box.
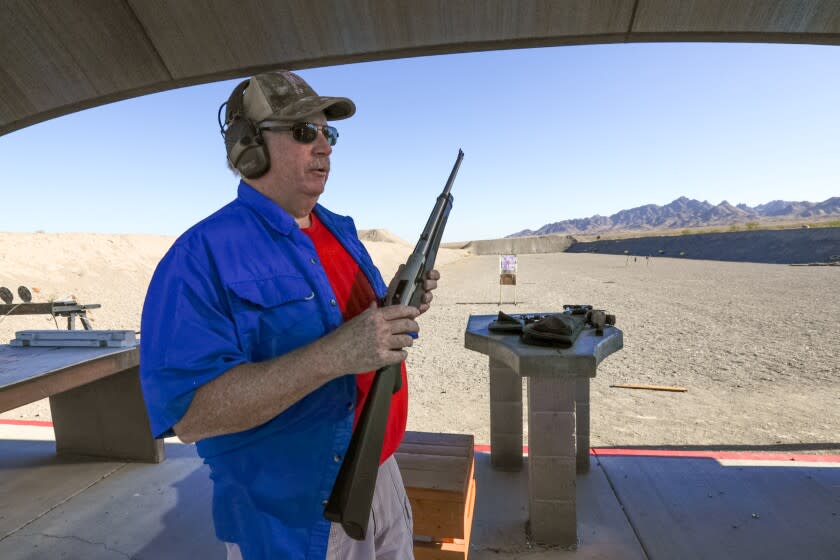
[464,315,623,546]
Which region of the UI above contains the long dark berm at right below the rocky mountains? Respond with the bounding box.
[567,228,840,264]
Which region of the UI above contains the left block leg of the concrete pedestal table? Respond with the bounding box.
[490,358,522,471]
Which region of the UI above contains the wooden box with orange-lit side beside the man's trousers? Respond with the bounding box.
[395,432,475,560]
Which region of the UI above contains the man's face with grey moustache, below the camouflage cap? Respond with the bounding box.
[255,113,332,218]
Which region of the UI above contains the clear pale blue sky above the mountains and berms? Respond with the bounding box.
[0,43,840,242]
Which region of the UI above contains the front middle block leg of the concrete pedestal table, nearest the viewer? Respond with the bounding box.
[528,377,577,546]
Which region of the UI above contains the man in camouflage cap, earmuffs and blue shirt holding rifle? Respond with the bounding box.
[140,72,439,560]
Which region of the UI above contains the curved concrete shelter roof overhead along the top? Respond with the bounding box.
[0,0,840,134]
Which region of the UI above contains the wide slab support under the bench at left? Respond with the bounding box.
[50,367,164,463]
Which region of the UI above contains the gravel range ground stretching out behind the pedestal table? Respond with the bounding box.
[409,253,840,453]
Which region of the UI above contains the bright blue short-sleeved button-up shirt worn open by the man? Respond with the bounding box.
[140,182,386,560]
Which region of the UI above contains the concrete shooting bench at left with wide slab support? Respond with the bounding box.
[0,344,164,463]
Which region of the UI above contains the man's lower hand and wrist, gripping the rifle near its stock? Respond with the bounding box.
[325,302,420,373]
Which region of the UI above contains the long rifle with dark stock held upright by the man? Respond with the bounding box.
[324,150,464,541]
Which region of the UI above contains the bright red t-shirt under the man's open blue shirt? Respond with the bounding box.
[301,212,408,464]
